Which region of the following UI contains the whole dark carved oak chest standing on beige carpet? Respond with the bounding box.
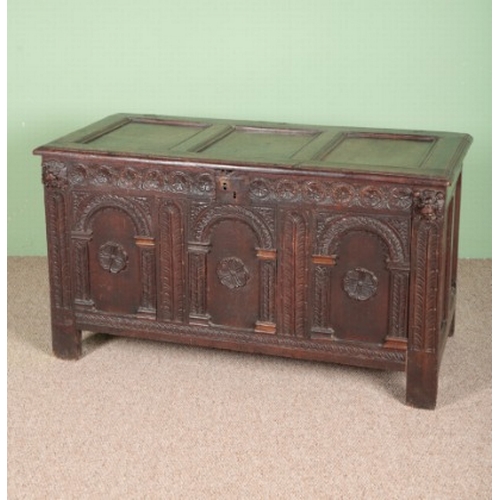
[35,114,471,408]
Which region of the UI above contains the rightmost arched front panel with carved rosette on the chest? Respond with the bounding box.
[312,214,409,345]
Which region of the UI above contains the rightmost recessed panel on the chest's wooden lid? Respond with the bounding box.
[321,134,435,168]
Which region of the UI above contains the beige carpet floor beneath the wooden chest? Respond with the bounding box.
[7,257,492,500]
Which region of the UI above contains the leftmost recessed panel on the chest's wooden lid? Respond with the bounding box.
[82,121,204,154]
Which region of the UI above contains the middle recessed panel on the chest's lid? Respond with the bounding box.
[197,127,318,160]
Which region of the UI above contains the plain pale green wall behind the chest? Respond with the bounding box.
[8,0,492,258]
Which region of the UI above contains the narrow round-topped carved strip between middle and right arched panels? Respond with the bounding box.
[279,211,309,337]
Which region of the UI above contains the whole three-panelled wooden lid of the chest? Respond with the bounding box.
[34,114,472,182]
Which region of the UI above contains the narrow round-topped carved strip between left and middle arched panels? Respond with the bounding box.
[159,202,185,321]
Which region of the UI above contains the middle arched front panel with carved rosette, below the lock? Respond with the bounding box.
[188,204,276,333]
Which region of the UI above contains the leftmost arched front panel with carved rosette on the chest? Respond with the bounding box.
[71,191,157,315]
